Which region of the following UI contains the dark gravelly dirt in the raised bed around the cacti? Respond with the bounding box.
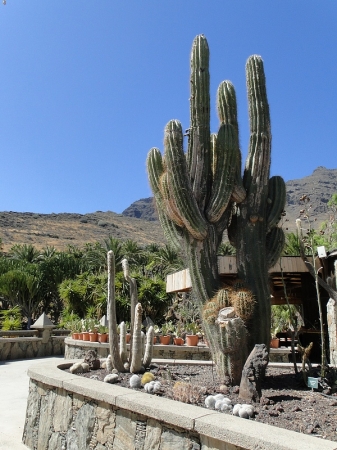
[70,364,337,441]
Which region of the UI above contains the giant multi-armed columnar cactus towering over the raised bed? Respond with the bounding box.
[147,35,285,384]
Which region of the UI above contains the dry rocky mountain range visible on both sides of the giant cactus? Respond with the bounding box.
[0,167,337,251]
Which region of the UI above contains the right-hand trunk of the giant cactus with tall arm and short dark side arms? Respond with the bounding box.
[224,55,286,350]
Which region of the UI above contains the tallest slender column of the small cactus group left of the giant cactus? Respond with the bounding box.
[107,250,124,372]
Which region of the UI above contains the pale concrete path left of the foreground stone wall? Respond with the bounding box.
[0,356,64,450]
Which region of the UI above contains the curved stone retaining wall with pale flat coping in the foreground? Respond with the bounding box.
[23,361,336,450]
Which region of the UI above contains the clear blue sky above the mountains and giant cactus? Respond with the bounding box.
[0,0,337,213]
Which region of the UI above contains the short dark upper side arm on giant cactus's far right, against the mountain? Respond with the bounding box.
[267,176,286,229]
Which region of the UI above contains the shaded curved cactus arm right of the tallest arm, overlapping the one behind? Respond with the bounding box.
[206,124,238,223]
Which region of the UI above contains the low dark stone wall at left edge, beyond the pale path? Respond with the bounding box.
[0,336,65,361]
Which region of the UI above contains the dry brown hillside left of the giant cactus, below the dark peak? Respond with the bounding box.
[0,211,164,251]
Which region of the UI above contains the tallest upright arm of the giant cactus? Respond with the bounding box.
[187,35,211,210]
